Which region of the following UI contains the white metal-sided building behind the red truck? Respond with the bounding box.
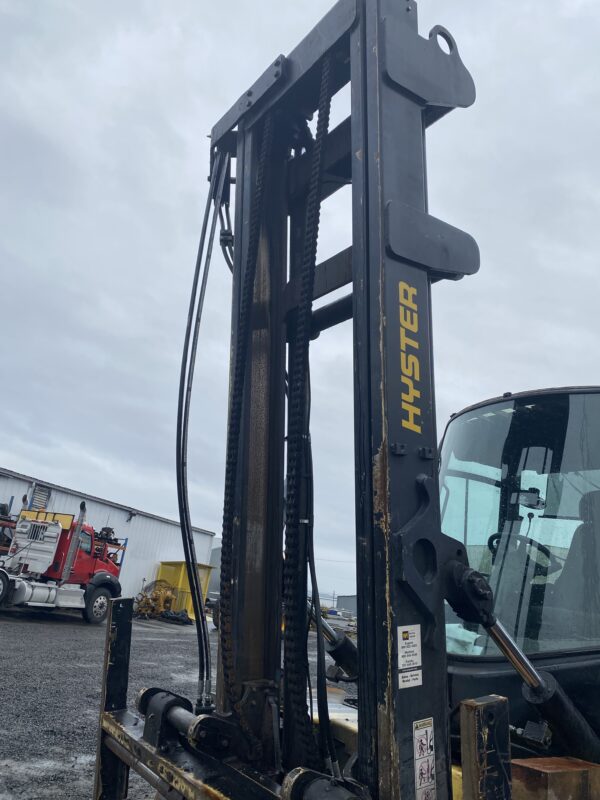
[0,467,214,596]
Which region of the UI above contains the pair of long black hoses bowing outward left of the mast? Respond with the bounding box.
[176,147,228,710]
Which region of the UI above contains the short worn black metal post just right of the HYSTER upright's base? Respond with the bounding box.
[460,695,511,800]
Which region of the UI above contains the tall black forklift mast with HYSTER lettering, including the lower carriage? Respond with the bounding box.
[95,0,482,800]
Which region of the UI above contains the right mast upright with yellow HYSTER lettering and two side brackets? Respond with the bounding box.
[350,0,477,800]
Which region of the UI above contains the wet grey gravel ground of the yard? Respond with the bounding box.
[0,609,346,800]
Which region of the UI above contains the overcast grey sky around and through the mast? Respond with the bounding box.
[0,0,600,594]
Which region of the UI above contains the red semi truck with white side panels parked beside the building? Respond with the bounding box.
[0,503,126,623]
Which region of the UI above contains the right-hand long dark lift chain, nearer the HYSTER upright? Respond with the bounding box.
[283,55,331,768]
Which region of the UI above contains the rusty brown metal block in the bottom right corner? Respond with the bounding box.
[512,757,600,800]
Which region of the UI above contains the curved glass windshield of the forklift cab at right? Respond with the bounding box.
[440,392,600,655]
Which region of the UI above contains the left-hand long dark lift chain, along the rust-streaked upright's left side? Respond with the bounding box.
[219,115,273,734]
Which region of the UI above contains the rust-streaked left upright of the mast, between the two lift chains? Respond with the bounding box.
[225,115,287,769]
